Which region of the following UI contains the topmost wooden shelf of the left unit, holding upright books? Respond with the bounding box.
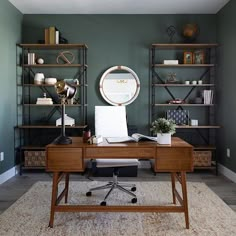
[17,43,88,49]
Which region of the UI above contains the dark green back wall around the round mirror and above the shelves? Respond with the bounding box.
[23,15,216,133]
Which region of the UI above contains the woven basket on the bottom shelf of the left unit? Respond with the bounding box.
[24,151,46,167]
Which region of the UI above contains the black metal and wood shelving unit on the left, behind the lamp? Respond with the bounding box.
[15,44,88,173]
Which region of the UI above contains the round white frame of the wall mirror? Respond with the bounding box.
[99,66,140,106]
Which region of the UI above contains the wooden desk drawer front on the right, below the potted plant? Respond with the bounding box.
[155,147,193,172]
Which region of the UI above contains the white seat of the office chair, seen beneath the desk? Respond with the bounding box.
[96,159,139,168]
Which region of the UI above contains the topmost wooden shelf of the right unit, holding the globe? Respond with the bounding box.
[152,43,219,49]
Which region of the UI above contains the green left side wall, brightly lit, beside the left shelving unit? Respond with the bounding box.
[0,0,23,174]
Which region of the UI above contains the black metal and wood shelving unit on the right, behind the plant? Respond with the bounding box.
[149,44,220,174]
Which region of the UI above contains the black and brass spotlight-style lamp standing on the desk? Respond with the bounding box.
[53,81,76,144]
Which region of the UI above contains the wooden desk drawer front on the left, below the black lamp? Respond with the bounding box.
[46,148,84,172]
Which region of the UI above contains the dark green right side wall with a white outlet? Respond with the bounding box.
[217,0,236,172]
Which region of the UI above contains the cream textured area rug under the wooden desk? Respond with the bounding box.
[0,181,236,236]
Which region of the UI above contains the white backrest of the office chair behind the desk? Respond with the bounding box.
[95,106,128,137]
